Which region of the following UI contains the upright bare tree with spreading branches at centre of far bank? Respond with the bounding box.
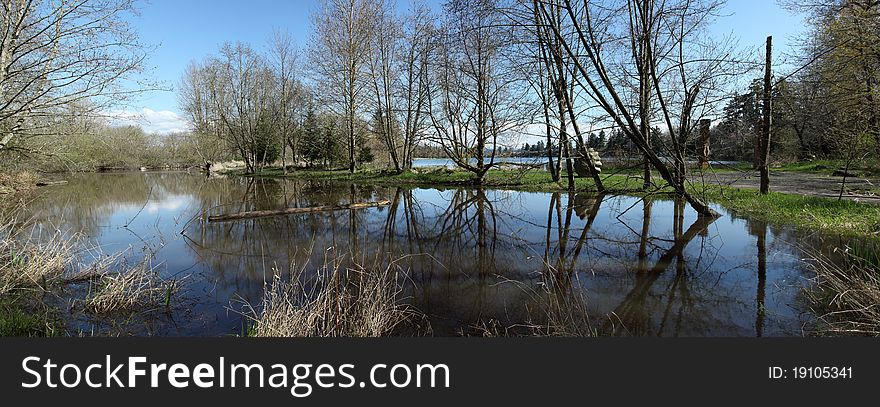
[428,0,527,182]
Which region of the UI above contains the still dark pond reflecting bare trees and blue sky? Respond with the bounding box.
[18,172,835,336]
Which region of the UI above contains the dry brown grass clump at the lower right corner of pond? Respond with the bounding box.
[807,249,880,336]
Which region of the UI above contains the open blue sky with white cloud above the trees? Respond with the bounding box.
[112,0,804,133]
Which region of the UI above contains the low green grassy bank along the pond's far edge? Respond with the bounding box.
[237,168,880,240]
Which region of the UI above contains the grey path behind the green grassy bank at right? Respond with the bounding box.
[704,171,880,205]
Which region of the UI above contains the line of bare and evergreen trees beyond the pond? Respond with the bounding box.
[0,0,880,215]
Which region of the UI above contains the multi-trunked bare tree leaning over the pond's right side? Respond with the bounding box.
[544,0,733,216]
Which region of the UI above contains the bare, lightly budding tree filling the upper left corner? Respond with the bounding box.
[0,0,150,156]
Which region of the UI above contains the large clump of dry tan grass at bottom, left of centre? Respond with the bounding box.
[245,258,420,337]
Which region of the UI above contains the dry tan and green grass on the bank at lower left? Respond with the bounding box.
[0,217,179,336]
